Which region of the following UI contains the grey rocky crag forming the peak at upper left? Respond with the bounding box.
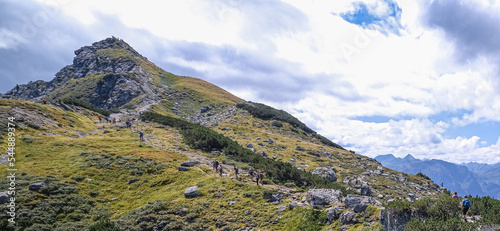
[2,37,167,109]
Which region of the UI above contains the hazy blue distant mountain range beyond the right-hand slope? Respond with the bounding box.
[375,154,500,198]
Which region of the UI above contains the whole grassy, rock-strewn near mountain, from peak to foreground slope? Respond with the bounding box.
[0,37,500,230]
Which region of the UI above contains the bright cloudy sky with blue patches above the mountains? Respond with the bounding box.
[0,0,500,163]
